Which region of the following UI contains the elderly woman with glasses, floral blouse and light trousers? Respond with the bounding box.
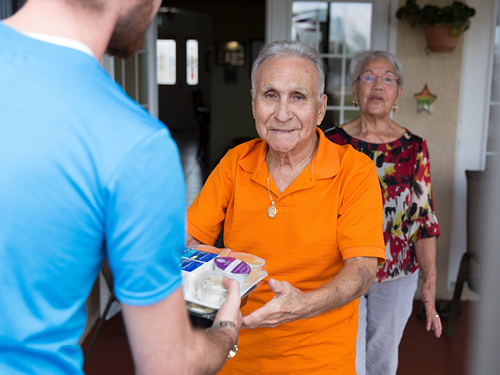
[325,51,442,375]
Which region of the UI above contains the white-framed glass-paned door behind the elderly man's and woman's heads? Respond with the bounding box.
[266,0,395,130]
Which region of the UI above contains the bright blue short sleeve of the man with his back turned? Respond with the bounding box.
[105,129,186,306]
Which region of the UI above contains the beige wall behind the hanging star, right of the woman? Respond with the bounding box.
[394,0,473,299]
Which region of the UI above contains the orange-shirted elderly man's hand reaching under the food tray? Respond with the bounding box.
[241,279,310,329]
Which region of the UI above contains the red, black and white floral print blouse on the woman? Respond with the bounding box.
[325,127,441,282]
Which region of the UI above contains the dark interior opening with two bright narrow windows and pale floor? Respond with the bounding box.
[156,7,213,206]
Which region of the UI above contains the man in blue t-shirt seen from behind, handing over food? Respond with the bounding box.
[0,0,241,375]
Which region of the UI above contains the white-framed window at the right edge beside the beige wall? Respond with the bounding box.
[448,0,498,290]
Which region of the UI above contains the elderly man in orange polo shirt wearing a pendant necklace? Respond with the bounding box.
[188,42,385,375]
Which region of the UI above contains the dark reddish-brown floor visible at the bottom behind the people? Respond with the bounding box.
[83,301,476,375]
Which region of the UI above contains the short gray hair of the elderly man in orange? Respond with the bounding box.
[251,40,325,101]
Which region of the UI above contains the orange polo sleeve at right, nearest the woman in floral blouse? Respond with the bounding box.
[337,149,385,263]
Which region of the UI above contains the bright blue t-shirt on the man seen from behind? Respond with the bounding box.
[0,22,185,375]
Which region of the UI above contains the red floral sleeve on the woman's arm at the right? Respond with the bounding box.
[409,139,441,243]
